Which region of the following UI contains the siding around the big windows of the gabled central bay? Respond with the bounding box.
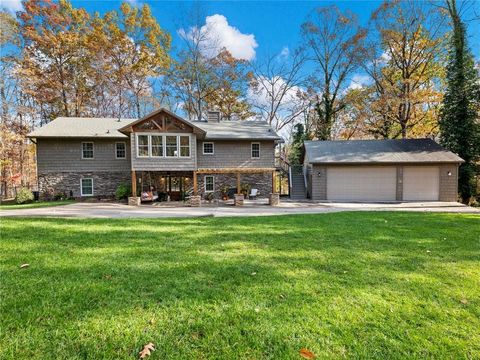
[130,133,197,171]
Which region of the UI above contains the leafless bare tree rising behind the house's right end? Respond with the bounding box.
[249,49,309,130]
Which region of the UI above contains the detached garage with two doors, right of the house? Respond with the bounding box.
[304,139,463,201]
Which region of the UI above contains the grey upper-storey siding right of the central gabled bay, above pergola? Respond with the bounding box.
[197,140,275,169]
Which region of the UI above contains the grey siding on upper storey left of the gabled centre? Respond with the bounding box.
[37,138,130,174]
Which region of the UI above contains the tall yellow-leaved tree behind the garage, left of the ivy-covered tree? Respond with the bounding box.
[363,1,443,138]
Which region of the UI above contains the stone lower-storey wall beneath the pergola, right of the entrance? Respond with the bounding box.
[198,173,272,199]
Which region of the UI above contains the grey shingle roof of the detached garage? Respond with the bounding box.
[305,139,463,164]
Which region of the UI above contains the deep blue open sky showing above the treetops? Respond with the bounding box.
[0,0,480,59]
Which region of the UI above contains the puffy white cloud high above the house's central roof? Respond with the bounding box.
[178,14,258,60]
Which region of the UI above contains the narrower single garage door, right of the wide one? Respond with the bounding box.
[403,166,440,201]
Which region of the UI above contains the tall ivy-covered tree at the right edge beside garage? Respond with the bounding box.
[440,0,480,203]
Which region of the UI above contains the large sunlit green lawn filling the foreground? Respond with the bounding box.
[0,212,480,360]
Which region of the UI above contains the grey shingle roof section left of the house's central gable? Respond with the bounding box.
[28,117,135,138]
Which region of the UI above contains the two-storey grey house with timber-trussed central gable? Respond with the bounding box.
[29,109,281,201]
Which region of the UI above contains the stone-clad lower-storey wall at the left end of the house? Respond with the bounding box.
[38,171,132,198]
